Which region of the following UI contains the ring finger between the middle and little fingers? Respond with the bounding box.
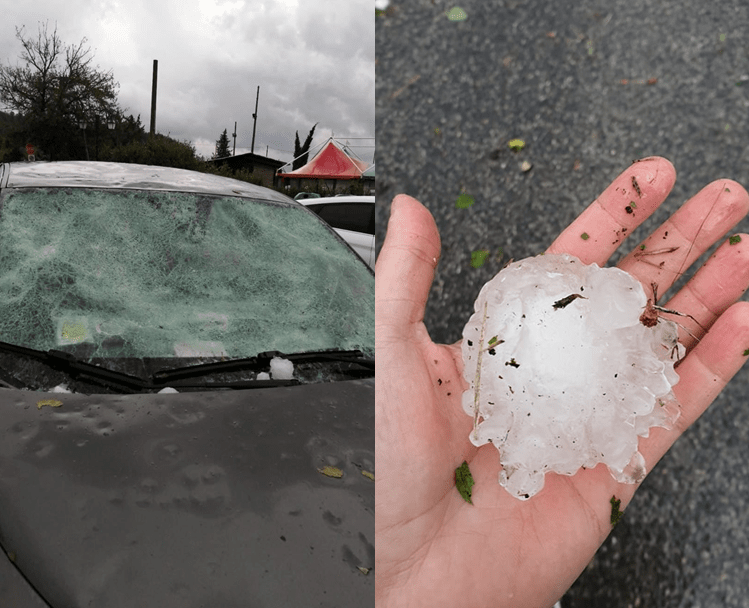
[660,234,749,350]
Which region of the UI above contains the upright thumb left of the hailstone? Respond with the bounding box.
[375,194,440,337]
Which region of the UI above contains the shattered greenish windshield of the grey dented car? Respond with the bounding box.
[0,188,374,360]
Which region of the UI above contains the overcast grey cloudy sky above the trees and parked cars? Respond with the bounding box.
[0,0,375,162]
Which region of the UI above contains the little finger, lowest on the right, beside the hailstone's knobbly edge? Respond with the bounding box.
[640,302,749,471]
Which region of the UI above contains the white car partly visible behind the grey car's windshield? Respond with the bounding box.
[301,195,375,268]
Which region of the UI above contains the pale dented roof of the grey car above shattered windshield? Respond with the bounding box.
[0,161,298,205]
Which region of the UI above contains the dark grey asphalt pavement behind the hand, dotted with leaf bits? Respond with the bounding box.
[376,0,749,608]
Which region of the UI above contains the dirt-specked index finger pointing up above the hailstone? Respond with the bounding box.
[547,156,676,266]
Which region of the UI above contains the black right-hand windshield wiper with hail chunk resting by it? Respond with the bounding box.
[153,350,375,382]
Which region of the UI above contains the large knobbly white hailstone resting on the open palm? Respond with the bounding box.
[462,255,683,499]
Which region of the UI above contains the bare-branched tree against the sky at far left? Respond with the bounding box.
[0,24,122,156]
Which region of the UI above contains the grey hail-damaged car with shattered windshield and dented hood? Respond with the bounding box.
[0,162,375,608]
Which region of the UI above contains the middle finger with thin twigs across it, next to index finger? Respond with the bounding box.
[618,180,749,293]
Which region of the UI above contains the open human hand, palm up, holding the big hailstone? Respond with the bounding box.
[375,157,749,608]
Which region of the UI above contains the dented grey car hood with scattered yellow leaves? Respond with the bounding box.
[0,379,374,608]
